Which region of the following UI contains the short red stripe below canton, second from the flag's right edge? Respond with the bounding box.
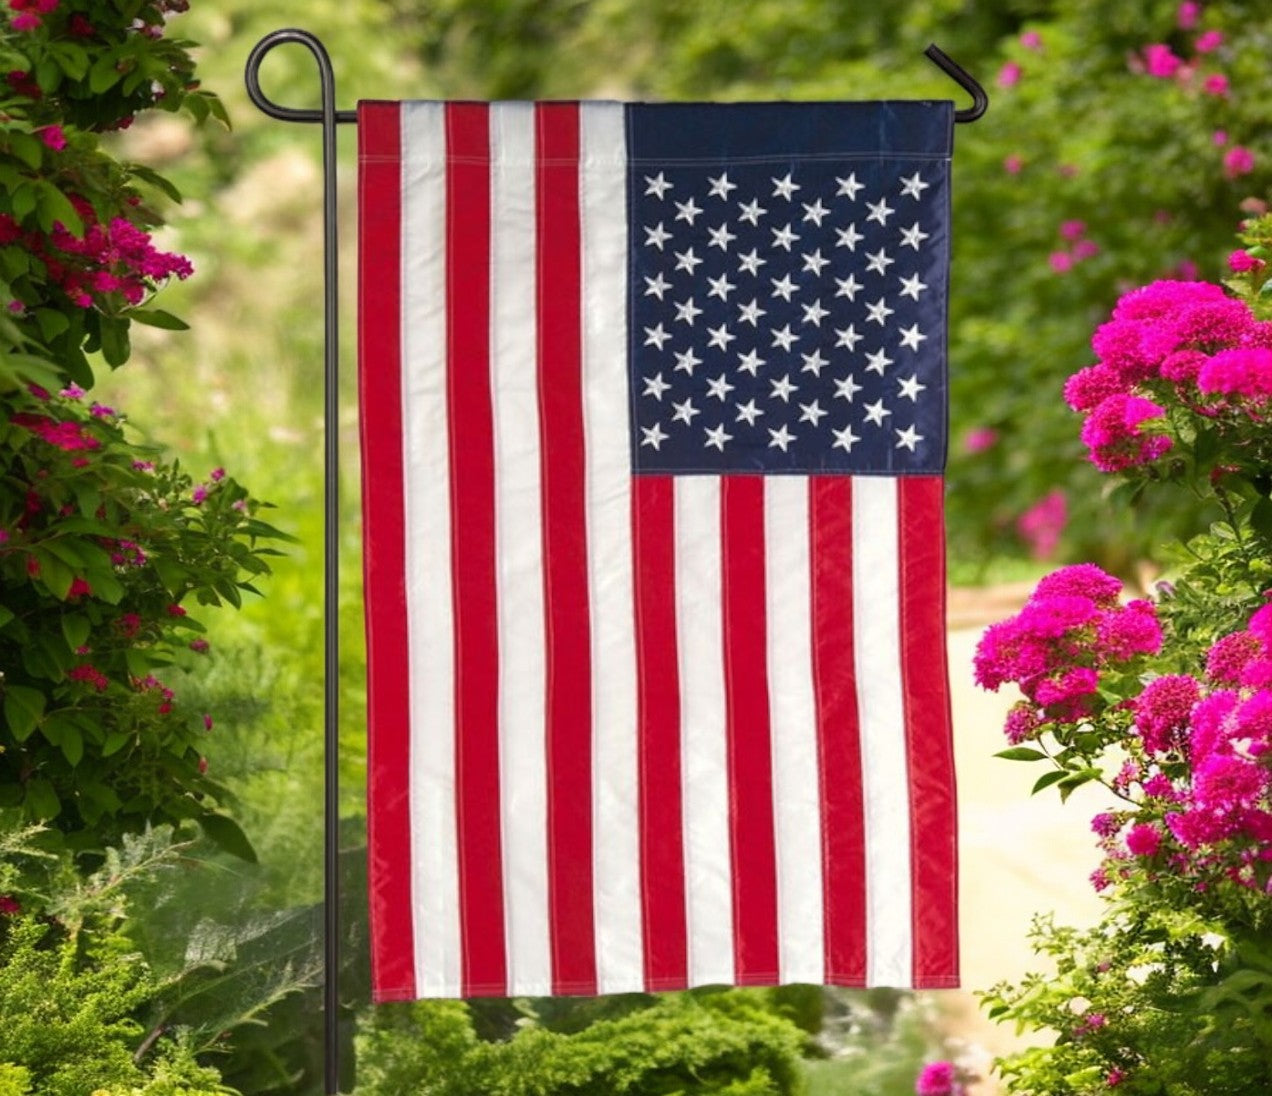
[809,476,866,985]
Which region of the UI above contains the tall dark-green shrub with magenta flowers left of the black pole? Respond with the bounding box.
[0,0,276,857]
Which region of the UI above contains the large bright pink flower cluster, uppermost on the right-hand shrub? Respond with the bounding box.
[1065,281,1272,472]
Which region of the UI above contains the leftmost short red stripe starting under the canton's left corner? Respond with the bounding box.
[632,476,688,990]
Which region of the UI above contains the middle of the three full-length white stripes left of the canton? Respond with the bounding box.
[490,103,552,994]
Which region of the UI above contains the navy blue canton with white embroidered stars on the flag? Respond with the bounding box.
[628,104,949,474]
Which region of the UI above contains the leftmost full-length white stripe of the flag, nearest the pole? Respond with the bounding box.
[399,103,460,997]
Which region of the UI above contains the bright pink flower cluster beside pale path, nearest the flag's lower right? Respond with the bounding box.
[973,563,1161,743]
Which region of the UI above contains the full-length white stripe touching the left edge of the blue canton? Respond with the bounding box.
[579,103,644,993]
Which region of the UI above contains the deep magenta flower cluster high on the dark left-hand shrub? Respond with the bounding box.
[0,196,195,308]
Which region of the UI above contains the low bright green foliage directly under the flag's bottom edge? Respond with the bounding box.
[359,990,804,1096]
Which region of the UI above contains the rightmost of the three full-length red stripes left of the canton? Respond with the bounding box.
[534,103,597,994]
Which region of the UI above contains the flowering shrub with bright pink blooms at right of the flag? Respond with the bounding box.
[974,244,1272,1096]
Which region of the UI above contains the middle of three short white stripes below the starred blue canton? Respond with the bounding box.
[764,476,826,984]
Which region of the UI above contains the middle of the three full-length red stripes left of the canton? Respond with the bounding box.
[446,103,508,997]
